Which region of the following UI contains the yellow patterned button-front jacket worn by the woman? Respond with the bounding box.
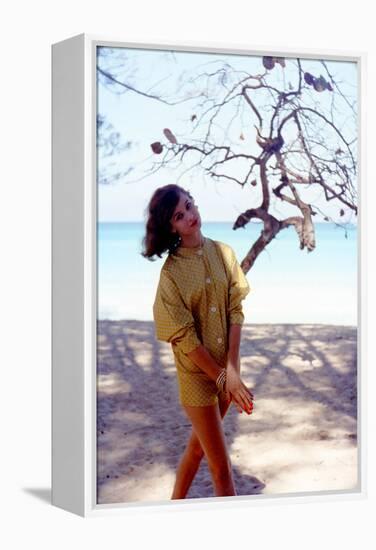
[153,238,250,404]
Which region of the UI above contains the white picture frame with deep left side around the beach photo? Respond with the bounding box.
[52,34,366,517]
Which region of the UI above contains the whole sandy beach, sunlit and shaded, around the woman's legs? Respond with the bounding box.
[97,321,358,504]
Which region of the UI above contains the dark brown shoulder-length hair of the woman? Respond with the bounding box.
[142,184,192,261]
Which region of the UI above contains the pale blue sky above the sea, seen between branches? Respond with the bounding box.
[97,48,357,223]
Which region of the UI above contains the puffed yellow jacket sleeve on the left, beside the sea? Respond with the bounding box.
[153,270,201,354]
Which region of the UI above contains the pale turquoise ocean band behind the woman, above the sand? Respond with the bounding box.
[97,222,358,326]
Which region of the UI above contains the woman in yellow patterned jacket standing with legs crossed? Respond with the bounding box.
[143,185,253,499]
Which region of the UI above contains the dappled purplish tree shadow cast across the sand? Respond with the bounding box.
[97,320,357,503]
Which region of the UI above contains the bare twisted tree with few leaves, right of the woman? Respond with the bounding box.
[96,57,357,273]
